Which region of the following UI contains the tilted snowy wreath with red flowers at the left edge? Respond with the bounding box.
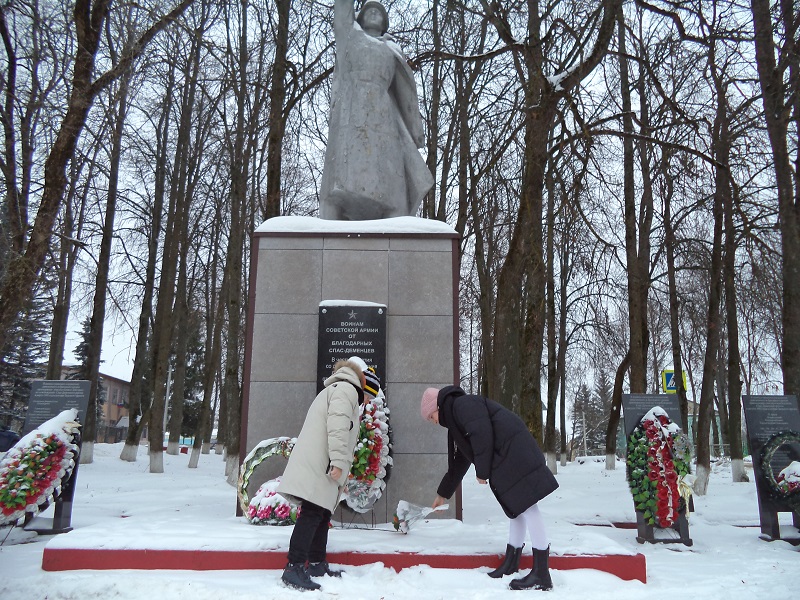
[0,409,80,526]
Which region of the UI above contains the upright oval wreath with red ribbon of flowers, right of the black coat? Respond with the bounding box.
[626,406,691,528]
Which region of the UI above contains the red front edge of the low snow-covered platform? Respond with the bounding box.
[42,548,647,583]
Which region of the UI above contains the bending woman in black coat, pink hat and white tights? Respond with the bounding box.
[420,385,558,590]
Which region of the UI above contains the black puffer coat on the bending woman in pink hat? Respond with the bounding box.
[437,385,558,519]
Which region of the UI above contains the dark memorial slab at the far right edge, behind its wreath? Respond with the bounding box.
[742,396,800,539]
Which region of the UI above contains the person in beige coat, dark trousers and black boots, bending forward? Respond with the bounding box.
[278,360,364,590]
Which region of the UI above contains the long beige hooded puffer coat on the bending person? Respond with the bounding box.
[278,367,361,512]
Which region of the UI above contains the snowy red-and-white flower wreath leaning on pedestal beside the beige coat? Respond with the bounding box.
[344,390,392,513]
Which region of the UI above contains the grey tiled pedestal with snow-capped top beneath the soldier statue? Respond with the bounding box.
[241,217,459,524]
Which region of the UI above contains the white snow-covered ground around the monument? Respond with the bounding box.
[0,444,800,600]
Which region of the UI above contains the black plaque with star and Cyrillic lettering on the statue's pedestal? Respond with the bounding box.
[317,301,386,393]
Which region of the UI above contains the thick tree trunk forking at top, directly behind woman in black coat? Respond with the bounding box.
[482,0,621,434]
